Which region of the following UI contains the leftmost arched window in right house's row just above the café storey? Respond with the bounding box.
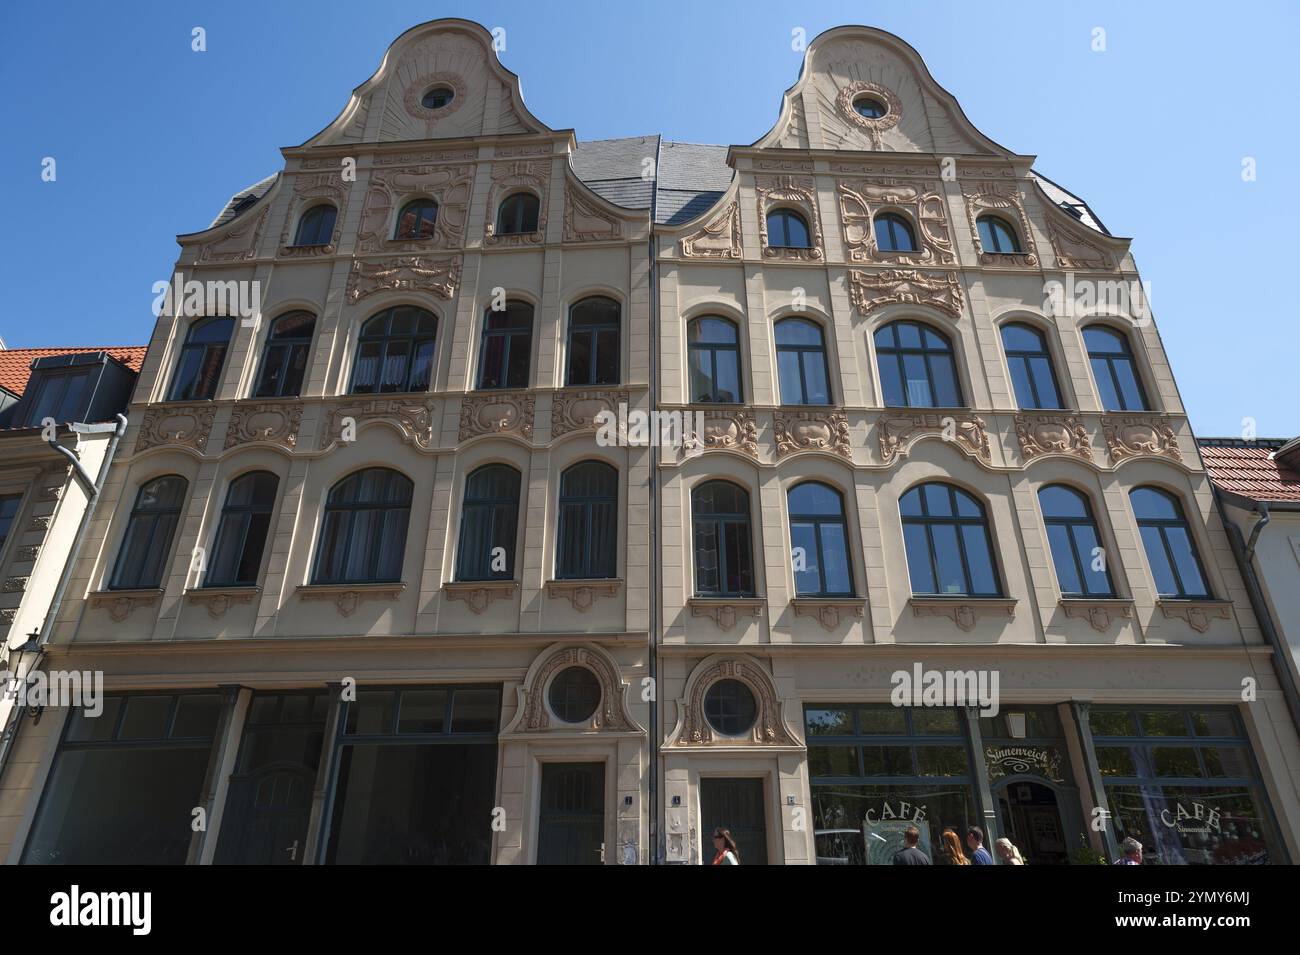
[690,481,754,596]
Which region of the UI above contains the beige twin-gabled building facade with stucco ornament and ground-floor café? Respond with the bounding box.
[0,19,1300,864]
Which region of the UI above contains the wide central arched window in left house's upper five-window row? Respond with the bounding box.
[352,305,438,395]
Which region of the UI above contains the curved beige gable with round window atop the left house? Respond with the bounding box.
[304,19,550,146]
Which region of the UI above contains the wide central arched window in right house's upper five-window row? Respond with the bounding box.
[875,321,962,408]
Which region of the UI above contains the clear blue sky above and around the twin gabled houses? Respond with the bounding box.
[0,0,1300,437]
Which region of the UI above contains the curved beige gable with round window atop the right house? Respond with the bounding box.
[754,26,1014,156]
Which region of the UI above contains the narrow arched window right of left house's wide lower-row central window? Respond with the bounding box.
[456,464,519,581]
